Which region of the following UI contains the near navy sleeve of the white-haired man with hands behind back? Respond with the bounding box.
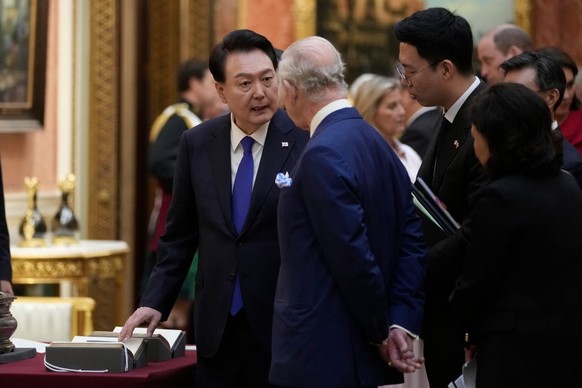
[302,147,388,343]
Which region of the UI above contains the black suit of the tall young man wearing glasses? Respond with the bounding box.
[418,83,487,388]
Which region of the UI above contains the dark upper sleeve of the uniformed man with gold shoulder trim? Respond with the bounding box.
[148,115,188,192]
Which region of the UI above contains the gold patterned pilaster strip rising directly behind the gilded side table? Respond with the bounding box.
[87,0,120,239]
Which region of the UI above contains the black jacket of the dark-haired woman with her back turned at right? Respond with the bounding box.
[456,172,582,388]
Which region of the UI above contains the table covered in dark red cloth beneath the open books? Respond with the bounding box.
[0,350,196,388]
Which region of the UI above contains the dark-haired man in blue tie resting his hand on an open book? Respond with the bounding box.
[119,30,308,387]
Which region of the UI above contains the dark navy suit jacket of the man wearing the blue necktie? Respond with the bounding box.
[140,110,309,357]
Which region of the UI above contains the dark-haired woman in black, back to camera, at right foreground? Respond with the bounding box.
[451,83,582,388]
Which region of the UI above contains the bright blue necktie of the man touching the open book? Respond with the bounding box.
[230,136,254,315]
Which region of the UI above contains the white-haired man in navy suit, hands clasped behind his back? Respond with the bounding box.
[270,37,425,387]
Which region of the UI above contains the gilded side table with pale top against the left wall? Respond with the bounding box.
[10,240,129,330]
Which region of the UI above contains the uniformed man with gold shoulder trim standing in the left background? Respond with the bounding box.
[145,58,227,336]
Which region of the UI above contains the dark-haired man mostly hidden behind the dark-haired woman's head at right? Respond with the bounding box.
[501,50,582,188]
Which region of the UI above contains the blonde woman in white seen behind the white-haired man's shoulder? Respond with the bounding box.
[351,74,422,182]
